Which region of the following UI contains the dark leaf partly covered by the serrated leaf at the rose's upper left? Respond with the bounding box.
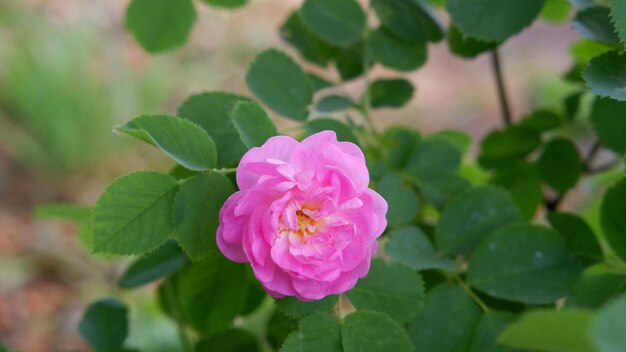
[178,92,251,167]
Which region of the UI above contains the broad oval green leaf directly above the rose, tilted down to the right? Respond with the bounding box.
[246,49,313,121]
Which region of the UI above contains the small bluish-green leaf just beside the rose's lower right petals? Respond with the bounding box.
[385,226,456,271]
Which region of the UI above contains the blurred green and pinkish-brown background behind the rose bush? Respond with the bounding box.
[0,0,601,352]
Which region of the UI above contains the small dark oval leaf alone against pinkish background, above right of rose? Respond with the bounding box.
[369,79,415,108]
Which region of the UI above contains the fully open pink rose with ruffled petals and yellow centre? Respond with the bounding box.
[217,131,387,301]
